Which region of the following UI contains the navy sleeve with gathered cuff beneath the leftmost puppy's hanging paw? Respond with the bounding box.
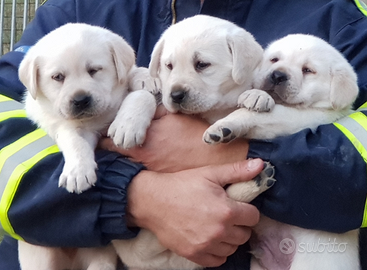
[7,152,141,246]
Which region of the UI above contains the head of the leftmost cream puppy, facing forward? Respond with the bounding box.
[19,24,135,119]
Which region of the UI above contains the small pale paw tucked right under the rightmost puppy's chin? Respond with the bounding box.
[238,89,275,112]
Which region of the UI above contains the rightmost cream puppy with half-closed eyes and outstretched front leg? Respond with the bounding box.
[203,34,360,270]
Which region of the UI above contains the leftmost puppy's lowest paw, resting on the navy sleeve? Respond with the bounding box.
[59,160,97,193]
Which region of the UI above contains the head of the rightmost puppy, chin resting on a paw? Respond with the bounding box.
[254,34,358,110]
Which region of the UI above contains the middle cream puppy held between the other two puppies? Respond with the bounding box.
[113,15,275,269]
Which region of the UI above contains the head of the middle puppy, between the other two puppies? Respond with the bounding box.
[149,15,263,114]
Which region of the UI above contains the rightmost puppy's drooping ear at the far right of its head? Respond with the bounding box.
[330,61,359,110]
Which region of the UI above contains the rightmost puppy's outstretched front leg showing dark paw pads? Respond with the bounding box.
[203,104,348,144]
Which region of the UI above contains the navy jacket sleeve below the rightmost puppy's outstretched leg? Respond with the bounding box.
[249,121,367,232]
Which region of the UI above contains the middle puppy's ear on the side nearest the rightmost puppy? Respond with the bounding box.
[227,29,263,84]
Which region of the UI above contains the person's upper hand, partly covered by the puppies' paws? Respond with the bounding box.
[99,107,248,172]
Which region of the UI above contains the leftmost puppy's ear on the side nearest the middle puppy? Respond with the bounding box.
[109,34,135,84]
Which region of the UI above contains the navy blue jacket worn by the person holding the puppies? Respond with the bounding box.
[0,0,367,270]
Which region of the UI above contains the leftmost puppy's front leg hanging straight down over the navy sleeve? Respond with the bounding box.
[56,126,99,193]
